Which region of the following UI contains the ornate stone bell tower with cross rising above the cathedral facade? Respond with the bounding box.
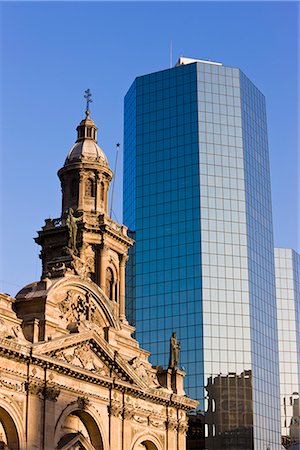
[35,90,134,321]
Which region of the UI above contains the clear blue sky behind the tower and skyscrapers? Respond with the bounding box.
[0,1,300,294]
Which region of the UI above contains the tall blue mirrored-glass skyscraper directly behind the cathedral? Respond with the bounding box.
[124,58,280,450]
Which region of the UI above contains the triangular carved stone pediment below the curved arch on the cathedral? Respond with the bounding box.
[34,331,148,388]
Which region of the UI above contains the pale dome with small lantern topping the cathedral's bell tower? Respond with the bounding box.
[65,110,109,167]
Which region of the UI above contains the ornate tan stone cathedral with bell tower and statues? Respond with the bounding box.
[0,101,197,450]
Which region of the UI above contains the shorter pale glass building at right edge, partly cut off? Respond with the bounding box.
[275,248,300,448]
